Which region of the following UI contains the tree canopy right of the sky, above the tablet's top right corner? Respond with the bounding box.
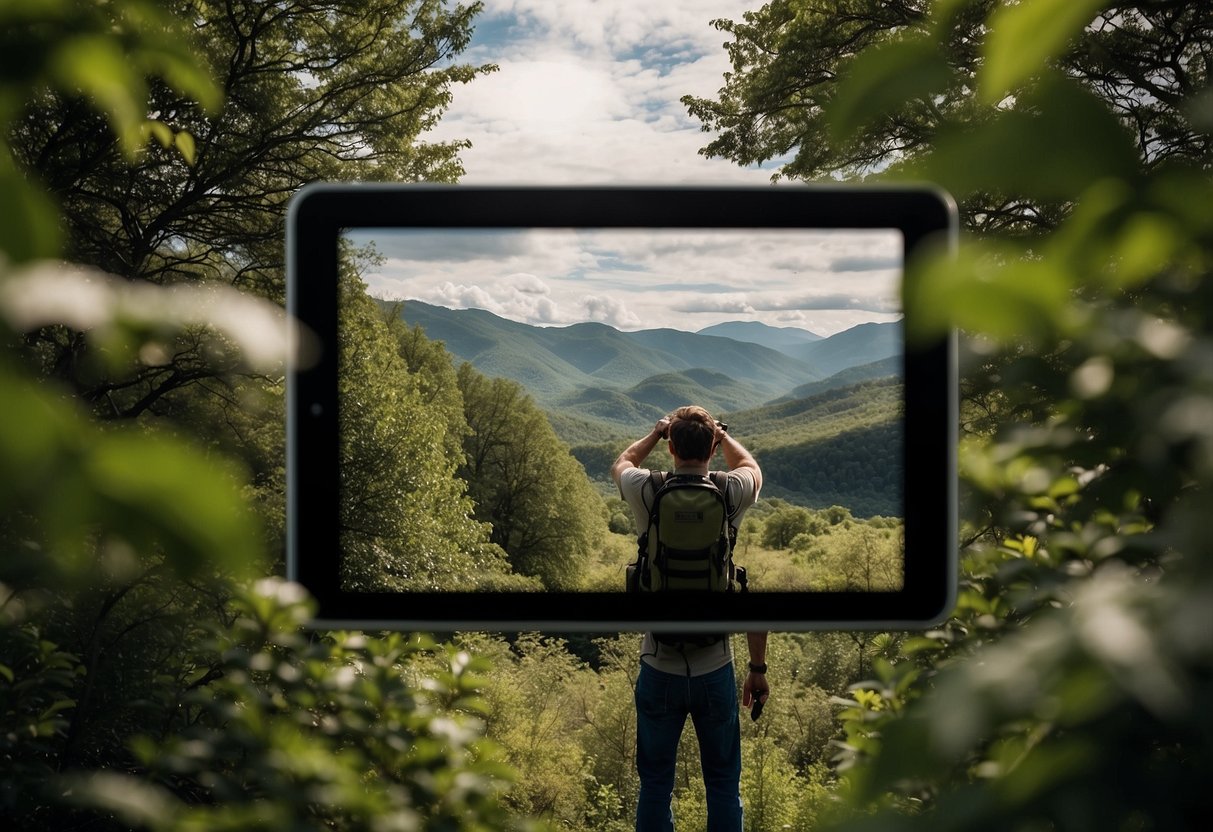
[683,0,1213,233]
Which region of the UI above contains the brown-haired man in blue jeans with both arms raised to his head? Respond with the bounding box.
[611,405,770,832]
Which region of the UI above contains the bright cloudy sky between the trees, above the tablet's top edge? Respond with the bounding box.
[431,0,773,184]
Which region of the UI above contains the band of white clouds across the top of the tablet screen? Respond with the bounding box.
[358,229,900,335]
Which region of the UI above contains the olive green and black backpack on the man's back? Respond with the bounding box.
[627,472,746,592]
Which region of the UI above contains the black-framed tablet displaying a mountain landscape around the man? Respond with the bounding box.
[286,183,957,633]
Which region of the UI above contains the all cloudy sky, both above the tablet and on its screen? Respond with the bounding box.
[352,0,900,336]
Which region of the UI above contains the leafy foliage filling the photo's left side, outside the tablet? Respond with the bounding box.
[0,0,540,830]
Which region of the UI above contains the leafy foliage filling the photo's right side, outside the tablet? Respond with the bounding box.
[689,0,1213,830]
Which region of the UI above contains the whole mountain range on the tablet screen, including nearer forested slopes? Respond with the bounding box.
[380,301,902,515]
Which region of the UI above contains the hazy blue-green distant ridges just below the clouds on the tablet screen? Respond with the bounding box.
[385,301,901,414]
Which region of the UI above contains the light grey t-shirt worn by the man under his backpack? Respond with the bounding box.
[619,468,758,676]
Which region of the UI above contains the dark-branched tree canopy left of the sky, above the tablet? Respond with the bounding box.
[7,0,492,417]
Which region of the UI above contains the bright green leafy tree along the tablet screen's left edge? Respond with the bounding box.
[337,260,519,592]
